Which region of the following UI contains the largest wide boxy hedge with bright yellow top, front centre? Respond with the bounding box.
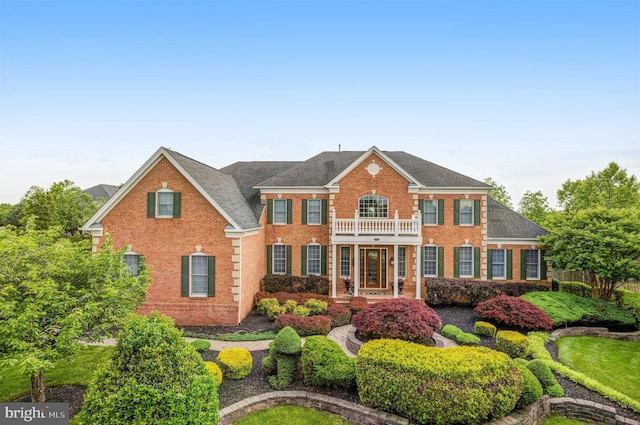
[356,339,522,425]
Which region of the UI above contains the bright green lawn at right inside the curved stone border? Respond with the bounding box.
[556,336,640,400]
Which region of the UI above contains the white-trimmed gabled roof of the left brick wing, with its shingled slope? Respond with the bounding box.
[82,148,260,230]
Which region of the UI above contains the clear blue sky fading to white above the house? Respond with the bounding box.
[0,0,640,205]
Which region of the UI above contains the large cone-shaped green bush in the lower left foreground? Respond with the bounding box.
[75,312,219,425]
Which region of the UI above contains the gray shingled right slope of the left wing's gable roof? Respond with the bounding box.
[166,149,260,229]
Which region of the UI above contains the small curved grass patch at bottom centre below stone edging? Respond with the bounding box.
[233,405,349,425]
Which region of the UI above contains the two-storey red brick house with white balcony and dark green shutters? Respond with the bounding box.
[82,146,547,325]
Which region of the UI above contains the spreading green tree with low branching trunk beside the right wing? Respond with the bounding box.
[539,207,640,300]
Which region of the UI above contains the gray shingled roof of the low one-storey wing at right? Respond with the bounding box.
[487,198,548,239]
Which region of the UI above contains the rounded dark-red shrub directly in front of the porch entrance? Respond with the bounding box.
[351,298,442,344]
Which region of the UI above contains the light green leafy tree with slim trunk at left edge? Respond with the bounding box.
[0,225,149,402]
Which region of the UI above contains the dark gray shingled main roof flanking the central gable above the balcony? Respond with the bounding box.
[258,151,490,189]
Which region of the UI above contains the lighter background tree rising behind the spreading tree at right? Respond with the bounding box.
[557,162,640,211]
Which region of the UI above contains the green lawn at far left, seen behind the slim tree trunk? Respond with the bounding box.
[0,346,113,402]
